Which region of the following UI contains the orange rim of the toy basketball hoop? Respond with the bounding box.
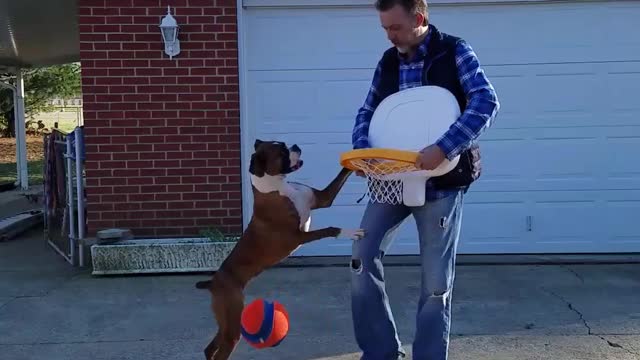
[340,148,419,171]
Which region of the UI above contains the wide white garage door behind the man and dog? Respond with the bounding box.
[243,1,640,255]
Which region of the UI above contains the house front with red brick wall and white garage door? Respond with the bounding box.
[78,0,640,255]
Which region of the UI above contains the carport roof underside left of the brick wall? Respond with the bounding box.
[0,0,80,71]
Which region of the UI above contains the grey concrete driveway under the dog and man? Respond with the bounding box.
[0,229,640,360]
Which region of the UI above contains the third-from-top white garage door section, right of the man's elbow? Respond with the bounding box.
[474,126,640,191]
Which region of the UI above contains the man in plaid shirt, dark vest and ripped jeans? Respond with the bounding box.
[351,0,499,360]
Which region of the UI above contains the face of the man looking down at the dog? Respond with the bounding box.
[380,5,423,53]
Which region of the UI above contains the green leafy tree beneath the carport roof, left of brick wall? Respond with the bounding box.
[0,63,82,137]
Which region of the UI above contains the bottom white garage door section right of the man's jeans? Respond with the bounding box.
[460,190,640,253]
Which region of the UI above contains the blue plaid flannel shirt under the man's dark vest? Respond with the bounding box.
[352,32,500,199]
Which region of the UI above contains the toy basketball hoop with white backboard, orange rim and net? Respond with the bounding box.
[340,86,460,206]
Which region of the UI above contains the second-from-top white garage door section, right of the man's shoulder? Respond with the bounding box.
[485,62,640,129]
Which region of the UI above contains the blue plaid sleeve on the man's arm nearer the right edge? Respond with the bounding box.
[436,40,500,160]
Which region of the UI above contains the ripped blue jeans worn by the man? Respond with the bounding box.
[351,191,463,360]
